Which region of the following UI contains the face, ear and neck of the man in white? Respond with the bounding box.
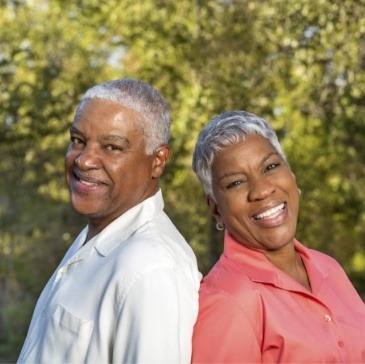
[65,99,162,230]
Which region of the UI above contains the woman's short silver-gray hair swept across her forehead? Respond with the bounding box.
[193,111,286,199]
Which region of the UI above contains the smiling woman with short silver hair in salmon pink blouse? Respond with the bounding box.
[192,111,365,363]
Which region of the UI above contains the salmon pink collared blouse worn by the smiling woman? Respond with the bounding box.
[192,232,365,363]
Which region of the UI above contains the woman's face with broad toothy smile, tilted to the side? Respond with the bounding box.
[208,135,299,251]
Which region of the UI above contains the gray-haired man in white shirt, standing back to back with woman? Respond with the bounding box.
[19,79,201,363]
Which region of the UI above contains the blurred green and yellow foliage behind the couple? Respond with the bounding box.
[0,0,365,361]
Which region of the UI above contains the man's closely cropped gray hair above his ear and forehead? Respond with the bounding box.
[81,78,171,154]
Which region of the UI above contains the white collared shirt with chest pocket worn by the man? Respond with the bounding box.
[18,191,201,364]
